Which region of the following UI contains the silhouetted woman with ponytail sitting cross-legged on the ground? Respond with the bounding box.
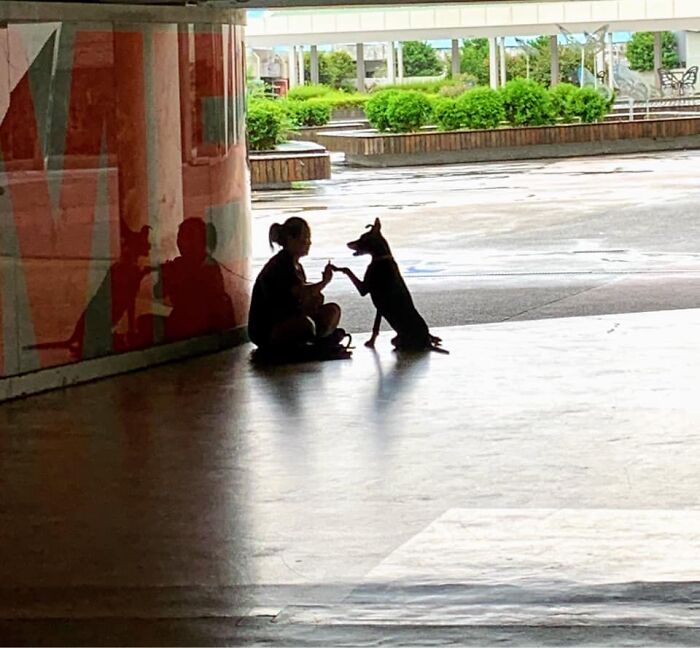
[248,216,349,360]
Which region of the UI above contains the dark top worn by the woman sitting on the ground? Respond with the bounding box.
[248,250,306,346]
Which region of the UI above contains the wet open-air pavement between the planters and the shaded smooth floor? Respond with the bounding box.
[253,151,700,331]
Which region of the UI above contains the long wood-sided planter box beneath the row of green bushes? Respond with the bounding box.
[318,117,700,167]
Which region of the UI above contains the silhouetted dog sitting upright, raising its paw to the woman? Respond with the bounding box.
[334,218,448,353]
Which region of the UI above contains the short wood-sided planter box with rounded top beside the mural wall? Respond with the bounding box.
[249,142,331,190]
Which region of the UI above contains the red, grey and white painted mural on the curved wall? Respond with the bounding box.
[0,23,250,377]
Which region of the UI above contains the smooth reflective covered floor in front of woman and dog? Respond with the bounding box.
[0,310,700,646]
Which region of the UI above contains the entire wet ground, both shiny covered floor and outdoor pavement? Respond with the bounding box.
[0,153,700,646]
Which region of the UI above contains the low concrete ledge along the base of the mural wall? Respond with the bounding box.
[0,326,248,402]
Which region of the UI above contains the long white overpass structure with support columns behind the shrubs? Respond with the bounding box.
[247,0,700,89]
